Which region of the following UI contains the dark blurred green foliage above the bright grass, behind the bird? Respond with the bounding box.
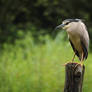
[0,0,92,43]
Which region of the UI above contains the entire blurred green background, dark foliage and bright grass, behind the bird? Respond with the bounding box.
[0,0,92,92]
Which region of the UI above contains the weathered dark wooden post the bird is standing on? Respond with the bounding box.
[64,63,85,92]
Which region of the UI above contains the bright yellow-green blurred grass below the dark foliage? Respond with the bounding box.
[0,33,92,92]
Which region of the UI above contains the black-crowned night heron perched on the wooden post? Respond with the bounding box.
[56,19,89,64]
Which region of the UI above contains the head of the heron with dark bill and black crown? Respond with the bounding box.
[55,19,81,30]
